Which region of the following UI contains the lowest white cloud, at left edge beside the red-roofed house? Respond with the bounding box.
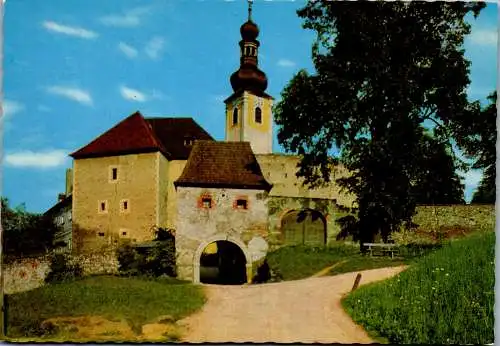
[5,150,68,168]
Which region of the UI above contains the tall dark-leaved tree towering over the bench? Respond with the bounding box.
[274,0,484,246]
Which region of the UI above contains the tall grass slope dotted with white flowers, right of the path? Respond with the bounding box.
[343,233,495,344]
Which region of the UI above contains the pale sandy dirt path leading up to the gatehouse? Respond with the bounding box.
[178,266,405,344]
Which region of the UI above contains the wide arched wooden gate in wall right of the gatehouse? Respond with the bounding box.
[281,209,326,246]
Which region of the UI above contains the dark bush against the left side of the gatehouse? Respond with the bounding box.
[117,229,177,277]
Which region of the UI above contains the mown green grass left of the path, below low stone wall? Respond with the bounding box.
[5,276,205,337]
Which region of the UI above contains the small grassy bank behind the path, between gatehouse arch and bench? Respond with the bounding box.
[267,243,409,281]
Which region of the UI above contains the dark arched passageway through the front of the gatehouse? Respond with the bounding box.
[200,240,247,285]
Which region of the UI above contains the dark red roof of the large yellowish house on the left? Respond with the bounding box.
[70,112,212,160]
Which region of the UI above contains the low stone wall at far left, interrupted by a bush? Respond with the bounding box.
[2,250,118,294]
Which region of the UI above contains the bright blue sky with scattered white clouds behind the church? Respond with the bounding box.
[1,0,497,212]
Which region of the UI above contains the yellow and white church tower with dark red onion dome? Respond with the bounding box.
[224,0,273,154]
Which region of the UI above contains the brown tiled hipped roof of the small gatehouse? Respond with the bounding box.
[175,140,271,191]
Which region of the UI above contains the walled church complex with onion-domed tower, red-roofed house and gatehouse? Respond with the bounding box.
[52,4,354,283]
